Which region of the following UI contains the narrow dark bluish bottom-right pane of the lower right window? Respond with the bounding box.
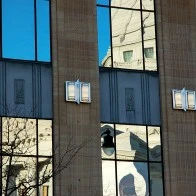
[150,163,163,196]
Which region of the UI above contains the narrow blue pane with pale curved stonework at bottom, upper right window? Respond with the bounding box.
[97,7,111,67]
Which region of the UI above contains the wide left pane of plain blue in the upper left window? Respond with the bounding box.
[2,0,35,60]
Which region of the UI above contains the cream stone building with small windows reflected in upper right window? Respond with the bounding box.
[101,0,157,70]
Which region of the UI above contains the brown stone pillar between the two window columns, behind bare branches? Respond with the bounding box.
[51,0,102,196]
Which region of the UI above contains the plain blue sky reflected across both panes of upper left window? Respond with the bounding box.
[2,0,50,62]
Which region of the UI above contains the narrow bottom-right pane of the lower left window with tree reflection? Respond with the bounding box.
[38,158,52,196]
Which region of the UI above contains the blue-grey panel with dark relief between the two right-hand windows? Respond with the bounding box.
[100,71,160,125]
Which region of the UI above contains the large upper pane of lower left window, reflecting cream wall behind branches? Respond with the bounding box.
[2,118,37,155]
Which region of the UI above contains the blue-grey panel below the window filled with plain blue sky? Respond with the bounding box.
[0,62,52,118]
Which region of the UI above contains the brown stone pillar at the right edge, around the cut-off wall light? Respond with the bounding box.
[155,0,196,196]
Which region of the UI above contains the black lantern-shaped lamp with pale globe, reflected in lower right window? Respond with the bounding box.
[101,129,115,156]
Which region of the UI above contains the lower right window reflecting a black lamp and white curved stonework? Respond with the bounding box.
[101,123,163,196]
